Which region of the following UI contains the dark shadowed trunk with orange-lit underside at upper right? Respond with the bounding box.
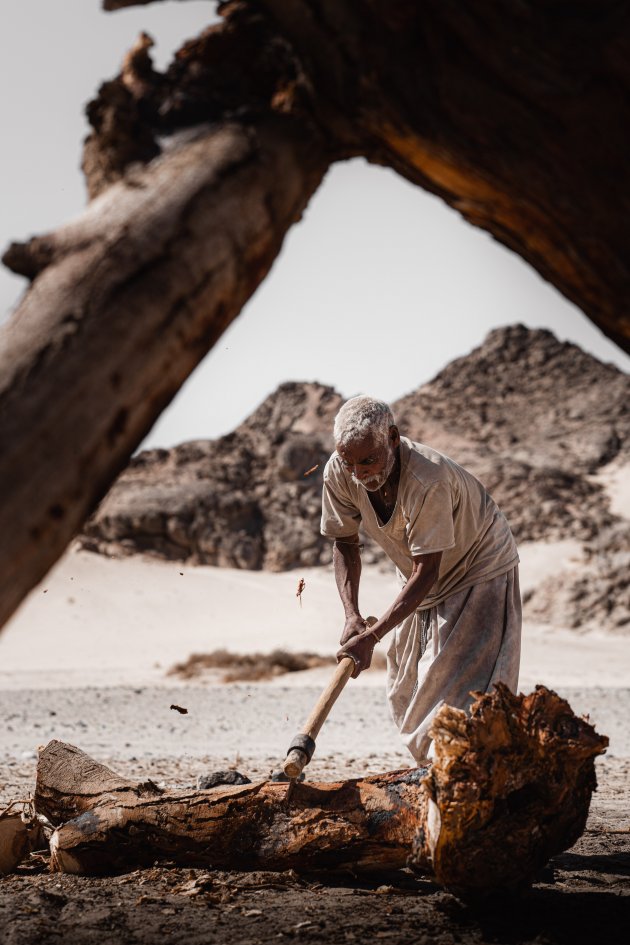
[99,0,630,350]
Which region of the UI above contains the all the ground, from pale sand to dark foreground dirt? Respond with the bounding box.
[0,528,630,945]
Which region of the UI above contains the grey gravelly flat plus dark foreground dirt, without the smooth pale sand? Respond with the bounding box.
[0,681,630,945]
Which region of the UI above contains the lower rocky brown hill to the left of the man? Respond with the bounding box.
[80,383,342,571]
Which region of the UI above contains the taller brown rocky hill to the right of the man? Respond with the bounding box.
[395,325,630,541]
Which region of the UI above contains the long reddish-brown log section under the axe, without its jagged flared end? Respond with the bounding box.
[35,741,425,874]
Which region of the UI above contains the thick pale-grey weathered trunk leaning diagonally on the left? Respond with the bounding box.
[0,116,326,624]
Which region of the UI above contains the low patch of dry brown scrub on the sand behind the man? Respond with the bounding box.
[167,650,386,683]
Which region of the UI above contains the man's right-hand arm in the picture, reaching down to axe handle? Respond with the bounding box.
[335,548,442,677]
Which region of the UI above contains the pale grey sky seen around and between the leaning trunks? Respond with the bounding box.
[0,0,630,446]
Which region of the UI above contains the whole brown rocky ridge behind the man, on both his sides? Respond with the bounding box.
[81,325,630,570]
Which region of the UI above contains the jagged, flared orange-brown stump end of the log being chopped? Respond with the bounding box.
[412,683,608,899]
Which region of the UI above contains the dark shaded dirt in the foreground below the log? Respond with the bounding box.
[0,759,630,945]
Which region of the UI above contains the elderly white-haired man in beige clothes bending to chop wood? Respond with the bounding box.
[321,396,521,764]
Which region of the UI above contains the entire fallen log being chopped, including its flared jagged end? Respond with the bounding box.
[35,686,608,898]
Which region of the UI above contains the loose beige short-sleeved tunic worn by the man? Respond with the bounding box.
[321,437,518,609]
